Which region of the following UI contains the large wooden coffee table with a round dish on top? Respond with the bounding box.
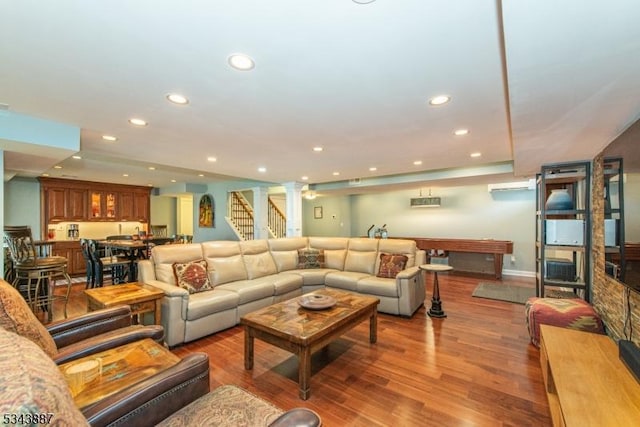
[240,289,380,400]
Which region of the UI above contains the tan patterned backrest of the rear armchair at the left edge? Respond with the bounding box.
[0,279,58,358]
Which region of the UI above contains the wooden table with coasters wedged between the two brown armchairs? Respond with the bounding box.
[59,338,180,409]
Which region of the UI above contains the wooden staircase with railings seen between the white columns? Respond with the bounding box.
[227,191,287,240]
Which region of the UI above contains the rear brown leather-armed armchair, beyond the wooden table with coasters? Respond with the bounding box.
[0,279,164,364]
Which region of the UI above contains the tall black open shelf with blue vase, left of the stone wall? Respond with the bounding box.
[536,162,591,301]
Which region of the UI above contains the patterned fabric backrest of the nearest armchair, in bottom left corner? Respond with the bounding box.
[0,330,89,427]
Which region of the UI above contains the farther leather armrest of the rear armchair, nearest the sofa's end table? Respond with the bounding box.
[45,305,131,348]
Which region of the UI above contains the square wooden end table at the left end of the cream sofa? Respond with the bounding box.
[84,282,164,325]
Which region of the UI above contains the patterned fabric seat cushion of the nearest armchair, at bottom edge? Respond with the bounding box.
[158,385,283,427]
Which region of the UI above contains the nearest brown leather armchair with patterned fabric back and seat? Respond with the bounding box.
[0,328,320,427]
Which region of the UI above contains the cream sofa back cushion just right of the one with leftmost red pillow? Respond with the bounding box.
[201,240,248,287]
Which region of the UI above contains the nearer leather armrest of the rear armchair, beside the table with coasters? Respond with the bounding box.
[53,325,164,365]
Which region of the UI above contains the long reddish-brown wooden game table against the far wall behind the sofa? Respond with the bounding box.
[402,237,513,279]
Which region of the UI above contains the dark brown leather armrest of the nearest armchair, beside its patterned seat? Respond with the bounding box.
[82,353,209,426]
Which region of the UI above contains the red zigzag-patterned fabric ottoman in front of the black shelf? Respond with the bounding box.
[525,297,604,348]
